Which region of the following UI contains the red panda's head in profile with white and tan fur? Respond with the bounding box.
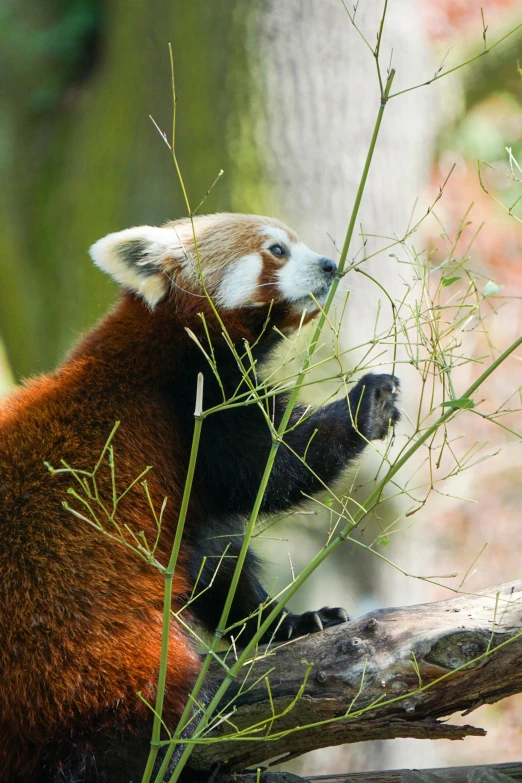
[90,213,337,325]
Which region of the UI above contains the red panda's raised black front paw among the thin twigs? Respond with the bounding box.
[350,373,401,440]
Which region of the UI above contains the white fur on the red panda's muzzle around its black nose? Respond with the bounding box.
[277,242,329,310]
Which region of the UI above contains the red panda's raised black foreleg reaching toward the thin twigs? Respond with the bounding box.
[197,374,400,514]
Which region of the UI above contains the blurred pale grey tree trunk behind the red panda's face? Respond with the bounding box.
[222,0,436,774]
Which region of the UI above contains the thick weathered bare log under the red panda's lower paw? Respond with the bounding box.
[191,580,522,780]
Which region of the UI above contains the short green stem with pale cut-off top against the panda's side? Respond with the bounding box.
[142,373,203,783]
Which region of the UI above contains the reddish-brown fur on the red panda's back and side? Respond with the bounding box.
[0,211,316,783]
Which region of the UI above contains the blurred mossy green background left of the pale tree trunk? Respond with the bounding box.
[0,0,270,377]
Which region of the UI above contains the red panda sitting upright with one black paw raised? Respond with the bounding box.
[0,214,399,783]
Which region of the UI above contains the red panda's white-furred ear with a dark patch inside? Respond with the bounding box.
[89,226,183,308]
